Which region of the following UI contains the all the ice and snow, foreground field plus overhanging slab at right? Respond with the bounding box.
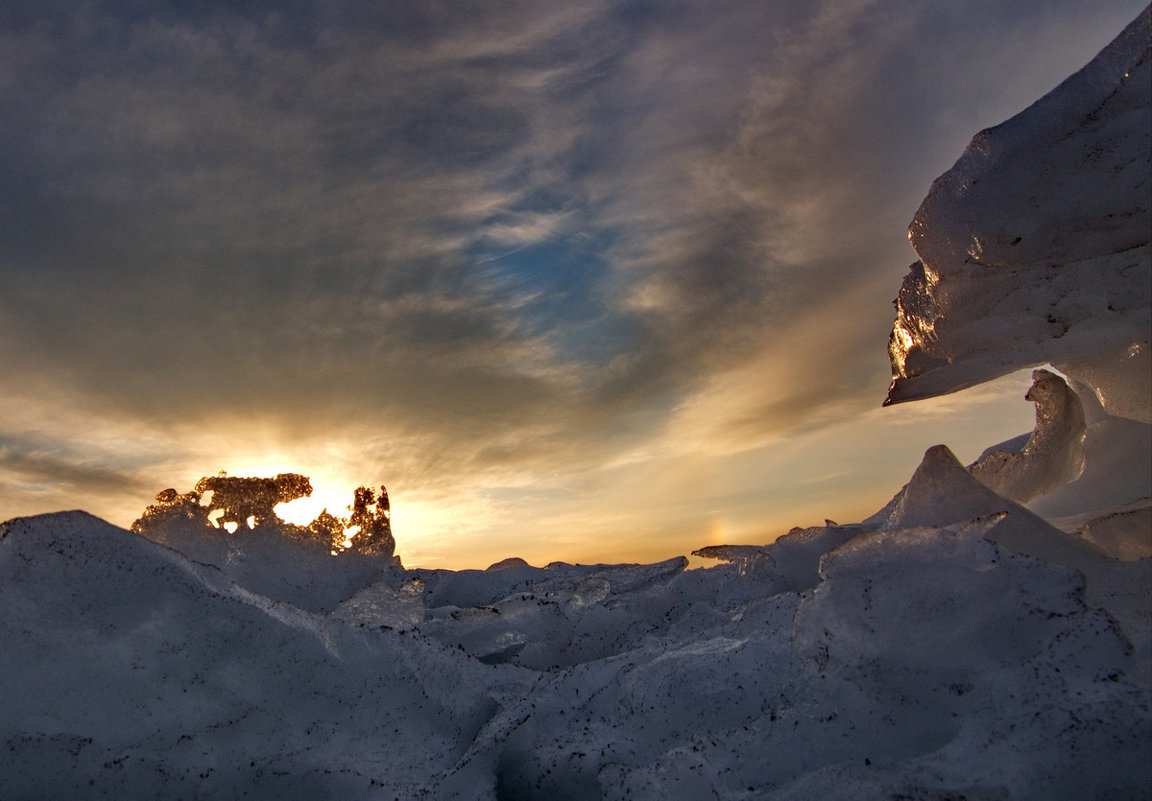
[0,12,1152,801]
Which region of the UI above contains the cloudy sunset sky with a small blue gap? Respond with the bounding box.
[0,0,1143,568]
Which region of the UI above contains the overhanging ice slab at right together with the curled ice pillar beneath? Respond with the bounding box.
[886,8,1152,567]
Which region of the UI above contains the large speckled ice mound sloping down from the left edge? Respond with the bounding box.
[0,513,504,799]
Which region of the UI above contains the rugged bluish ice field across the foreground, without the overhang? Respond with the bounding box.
[0,504,1152,800]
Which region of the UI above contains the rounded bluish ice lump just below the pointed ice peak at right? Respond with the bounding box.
[794,519,1087,677]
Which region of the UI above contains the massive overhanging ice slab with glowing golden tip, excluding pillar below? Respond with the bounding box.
[888,9,1152,423]
